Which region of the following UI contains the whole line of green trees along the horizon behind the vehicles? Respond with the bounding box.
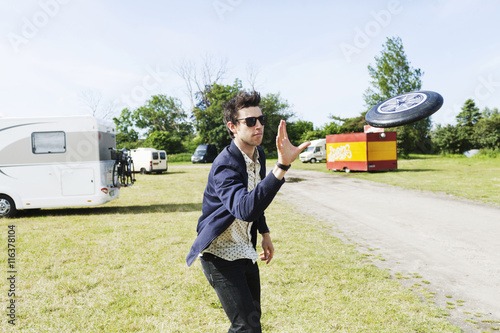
[113,37,500,157]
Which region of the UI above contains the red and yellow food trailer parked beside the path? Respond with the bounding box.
[326,132,398,172]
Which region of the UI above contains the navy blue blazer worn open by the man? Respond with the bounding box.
[186,141,285,266]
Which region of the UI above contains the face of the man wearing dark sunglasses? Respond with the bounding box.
[232,106,264,147]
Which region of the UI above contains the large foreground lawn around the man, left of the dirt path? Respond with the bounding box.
[0,164,460,333]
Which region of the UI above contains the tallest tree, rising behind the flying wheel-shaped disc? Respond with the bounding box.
[363,37,431,156]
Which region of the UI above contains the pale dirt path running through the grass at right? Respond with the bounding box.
[280,169,500,332]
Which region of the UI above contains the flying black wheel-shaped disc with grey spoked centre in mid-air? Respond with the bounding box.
[365,90,443,127]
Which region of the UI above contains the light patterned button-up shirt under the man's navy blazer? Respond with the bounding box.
[203,149,261,263]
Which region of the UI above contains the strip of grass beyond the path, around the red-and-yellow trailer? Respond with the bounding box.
[286,155,500,206]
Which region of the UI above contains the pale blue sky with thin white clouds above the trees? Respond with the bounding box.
[0,0,500,128]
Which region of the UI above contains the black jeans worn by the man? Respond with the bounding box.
[200,253,262,333]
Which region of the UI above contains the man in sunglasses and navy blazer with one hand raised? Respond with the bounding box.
[186,91,310,332]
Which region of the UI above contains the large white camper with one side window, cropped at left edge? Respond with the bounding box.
[0,116,119,217]
